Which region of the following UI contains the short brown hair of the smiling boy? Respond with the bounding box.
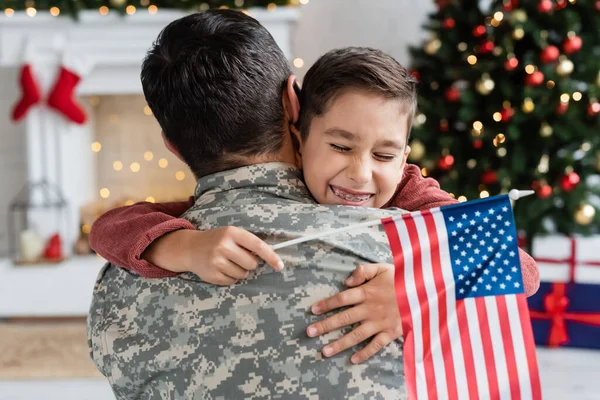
[298,47,417,140]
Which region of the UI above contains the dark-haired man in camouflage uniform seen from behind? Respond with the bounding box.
[88,10,406,399]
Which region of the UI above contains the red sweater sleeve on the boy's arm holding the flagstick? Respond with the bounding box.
[89,197,196,278]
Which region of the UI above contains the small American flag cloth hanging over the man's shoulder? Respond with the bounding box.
[383,195,542,400]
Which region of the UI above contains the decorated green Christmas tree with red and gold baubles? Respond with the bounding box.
[410,0,600,244]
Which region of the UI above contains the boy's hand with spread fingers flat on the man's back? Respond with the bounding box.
[306,264,402,364]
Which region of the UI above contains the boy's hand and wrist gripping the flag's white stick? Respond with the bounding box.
[142,226,283,285]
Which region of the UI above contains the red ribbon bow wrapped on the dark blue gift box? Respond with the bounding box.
[529,283,600,347]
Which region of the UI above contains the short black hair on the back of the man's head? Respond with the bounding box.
[141,10,291,178]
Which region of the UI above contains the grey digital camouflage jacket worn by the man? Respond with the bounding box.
[88,163,406,399]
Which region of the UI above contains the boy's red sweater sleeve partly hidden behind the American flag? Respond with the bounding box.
[386,164,540,296]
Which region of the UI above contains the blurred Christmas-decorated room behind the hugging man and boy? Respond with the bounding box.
[0,0,600,399]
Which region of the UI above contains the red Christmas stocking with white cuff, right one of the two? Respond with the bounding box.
[48,49,93,125]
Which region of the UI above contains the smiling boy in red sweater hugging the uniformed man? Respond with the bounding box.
[90,48,539,295]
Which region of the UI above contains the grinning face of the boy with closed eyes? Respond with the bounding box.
[300,90,410,208]
